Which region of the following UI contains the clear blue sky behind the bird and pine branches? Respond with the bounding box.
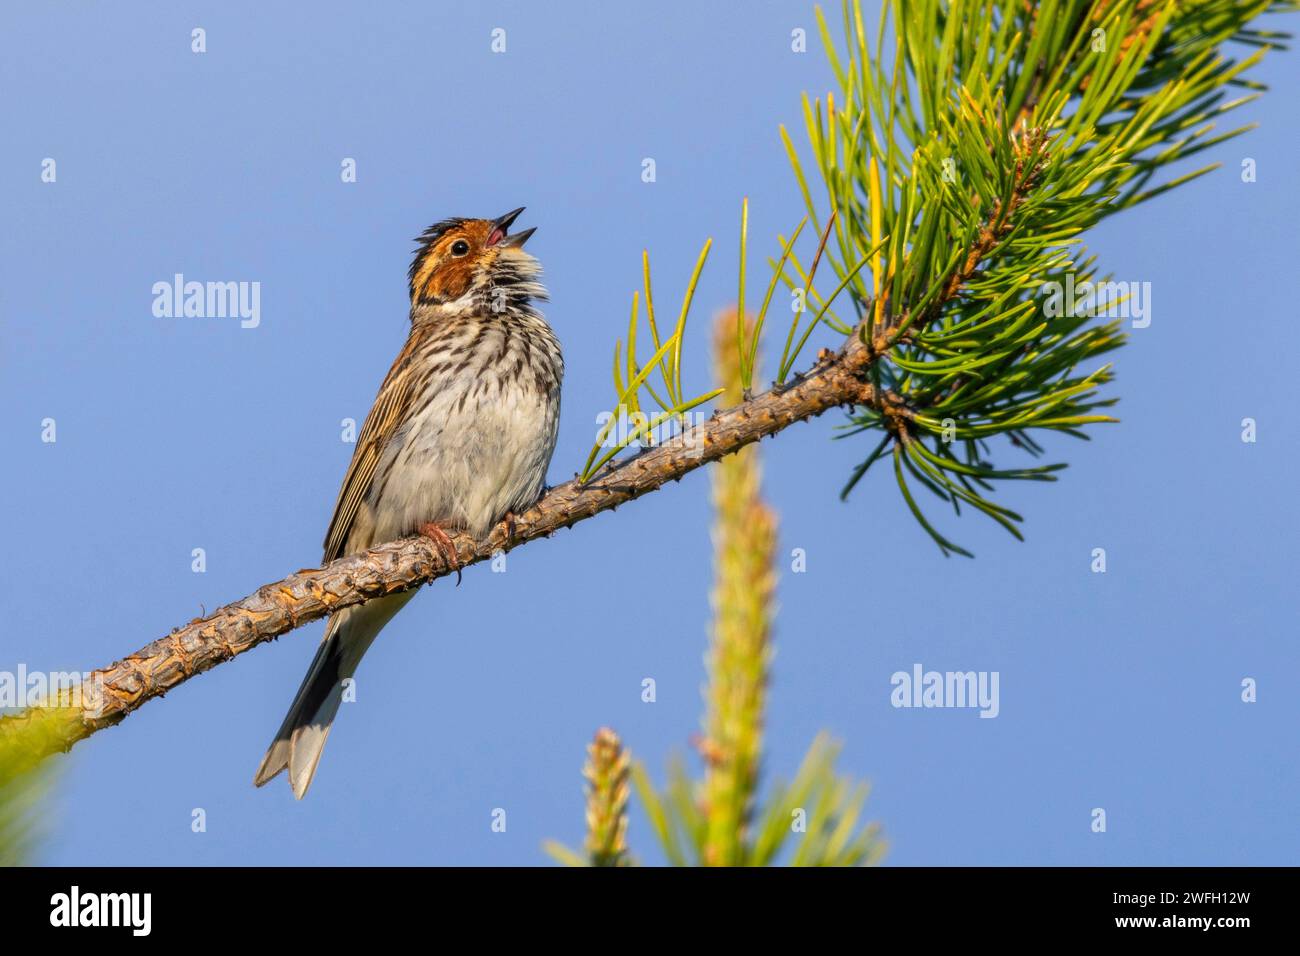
[0,3,1300,865]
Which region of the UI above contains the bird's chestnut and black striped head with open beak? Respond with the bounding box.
[408,207,546,311]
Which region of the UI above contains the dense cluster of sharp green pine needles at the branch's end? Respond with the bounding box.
[783,0,1300,555]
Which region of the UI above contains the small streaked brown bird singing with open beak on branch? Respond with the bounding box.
[254,208,564,800]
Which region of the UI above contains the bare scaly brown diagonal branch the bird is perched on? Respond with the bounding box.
[0,334,874,760]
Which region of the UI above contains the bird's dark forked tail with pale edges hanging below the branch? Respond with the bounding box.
[252,591,415,800]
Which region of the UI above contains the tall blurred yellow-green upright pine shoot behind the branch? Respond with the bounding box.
[618,312,885,866]
